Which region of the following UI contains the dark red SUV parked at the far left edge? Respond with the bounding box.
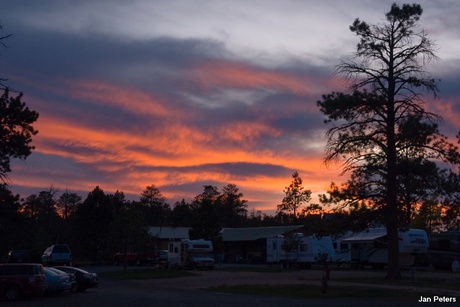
[0,263,46,301]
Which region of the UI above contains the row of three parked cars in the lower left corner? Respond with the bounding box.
[0,263,99,301]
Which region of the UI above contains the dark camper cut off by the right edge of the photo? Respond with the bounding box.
[428,229,460,271]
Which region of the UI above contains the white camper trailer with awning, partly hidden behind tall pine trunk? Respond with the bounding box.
[342,228,428,268]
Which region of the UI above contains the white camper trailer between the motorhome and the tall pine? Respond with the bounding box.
[267,233,335,268]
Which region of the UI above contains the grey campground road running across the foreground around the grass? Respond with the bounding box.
[10,268,460,307]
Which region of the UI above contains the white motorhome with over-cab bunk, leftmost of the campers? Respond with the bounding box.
[168,240,214,269]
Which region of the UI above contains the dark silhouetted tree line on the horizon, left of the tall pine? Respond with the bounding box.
[0,184,328,261]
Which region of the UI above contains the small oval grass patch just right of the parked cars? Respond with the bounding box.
[99,269,199,280]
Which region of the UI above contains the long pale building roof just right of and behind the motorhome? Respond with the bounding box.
[221,225,303,242]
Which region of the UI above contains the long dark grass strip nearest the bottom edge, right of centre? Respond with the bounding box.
[205,284,422,301]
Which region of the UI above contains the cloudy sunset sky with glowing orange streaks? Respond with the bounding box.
[0,0,460,214]
